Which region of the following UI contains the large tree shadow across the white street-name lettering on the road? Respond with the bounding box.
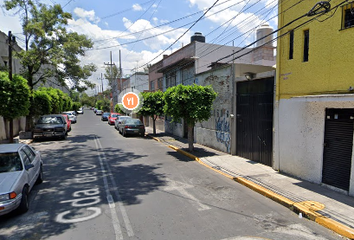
[0,135,165,240]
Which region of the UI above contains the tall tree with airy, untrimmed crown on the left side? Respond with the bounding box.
[4,0,96,130]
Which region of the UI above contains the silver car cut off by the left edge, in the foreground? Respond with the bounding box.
[0,143,43,215]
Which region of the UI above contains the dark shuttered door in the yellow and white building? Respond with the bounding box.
[322,109,354,191]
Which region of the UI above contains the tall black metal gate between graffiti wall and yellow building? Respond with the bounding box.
[236,78,274,166]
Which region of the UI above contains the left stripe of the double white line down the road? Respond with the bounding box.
[95,138,123,240]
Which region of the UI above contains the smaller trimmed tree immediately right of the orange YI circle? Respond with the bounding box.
[139,91,165,135]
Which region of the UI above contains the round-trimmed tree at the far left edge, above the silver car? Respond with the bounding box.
[0,72,31,142]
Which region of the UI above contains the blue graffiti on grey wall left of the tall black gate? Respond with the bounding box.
[214,109,231,153]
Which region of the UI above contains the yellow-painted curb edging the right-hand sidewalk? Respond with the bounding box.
[147,135,354,239]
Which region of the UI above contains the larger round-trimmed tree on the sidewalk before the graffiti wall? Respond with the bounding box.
[164,84,217,152]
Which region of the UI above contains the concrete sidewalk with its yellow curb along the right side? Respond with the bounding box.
[146,127,354,239]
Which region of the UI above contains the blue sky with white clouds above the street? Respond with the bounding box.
[0,0,278,94]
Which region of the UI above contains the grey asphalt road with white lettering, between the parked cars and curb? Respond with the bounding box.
[0,110,343,240]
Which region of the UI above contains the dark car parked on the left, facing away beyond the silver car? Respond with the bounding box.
[33,114,68,139]
